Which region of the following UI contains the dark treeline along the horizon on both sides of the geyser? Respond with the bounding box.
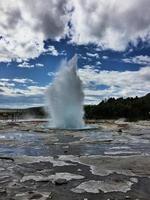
[0,93,150,121]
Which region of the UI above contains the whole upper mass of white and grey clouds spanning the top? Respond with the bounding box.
[0,0,150,62]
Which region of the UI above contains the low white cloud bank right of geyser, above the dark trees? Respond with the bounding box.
[78,66,150,103]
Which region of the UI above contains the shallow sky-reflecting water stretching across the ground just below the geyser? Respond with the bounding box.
[0,126,150,156]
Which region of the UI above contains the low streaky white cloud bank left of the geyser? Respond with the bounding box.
[0,78,47,108]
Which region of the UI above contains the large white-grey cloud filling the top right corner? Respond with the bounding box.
[71,0,150,51]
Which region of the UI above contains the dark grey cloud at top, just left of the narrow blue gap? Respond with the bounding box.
[23,0,68,40]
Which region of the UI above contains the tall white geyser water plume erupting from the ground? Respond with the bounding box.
[47,55,84,129]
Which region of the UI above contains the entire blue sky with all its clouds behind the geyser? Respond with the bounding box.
[0,0,150,108]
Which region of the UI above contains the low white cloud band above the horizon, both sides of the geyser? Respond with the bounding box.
[0,65,150,105]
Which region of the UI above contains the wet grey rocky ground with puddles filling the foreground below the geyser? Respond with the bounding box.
[0,120,150,200]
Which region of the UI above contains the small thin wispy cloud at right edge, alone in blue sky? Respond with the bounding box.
[123,55,150,65]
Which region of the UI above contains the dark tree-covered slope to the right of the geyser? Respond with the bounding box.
[85,93,150,120]
